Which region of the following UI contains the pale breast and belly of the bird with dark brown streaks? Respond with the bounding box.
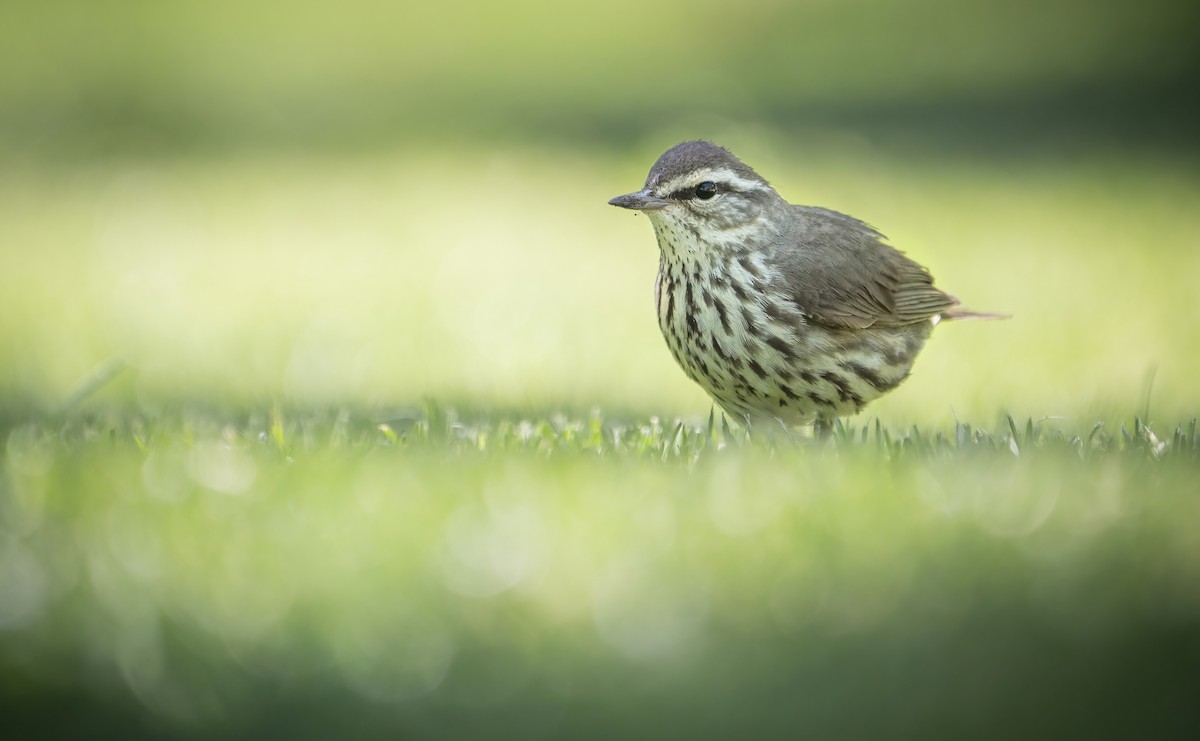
[655,265,931,424]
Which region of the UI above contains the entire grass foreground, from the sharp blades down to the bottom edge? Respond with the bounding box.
[0,404,1200,739]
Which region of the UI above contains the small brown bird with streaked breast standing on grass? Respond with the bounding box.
[608,141,1002,426]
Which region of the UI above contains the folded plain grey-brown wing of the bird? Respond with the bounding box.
[775,206,959,330]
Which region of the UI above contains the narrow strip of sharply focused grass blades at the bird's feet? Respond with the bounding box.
[20,402,1200,465]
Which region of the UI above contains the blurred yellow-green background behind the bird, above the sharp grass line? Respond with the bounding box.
[0,0,1200,423]
